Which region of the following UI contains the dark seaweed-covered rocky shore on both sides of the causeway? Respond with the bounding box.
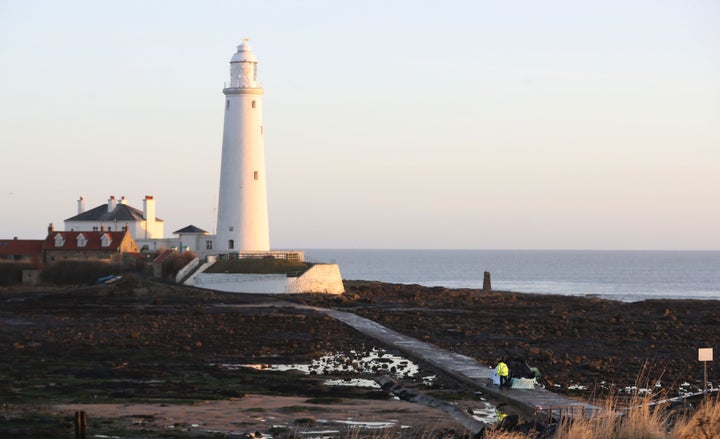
[0,279,720,437]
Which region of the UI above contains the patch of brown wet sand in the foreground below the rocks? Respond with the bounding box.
[51,395,481,435]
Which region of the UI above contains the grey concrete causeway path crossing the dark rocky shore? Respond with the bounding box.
[312,307,600,417]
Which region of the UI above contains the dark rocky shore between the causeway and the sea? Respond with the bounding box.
[298,281,720,395]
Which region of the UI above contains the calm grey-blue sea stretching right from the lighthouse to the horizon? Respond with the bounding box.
[305,249,720,302]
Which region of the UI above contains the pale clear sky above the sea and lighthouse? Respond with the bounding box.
[0,0,720,250]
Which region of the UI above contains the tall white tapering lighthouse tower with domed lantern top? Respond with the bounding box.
[216,39,270,253]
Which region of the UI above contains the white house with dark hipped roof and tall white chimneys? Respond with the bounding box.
[65,195,165,245]
